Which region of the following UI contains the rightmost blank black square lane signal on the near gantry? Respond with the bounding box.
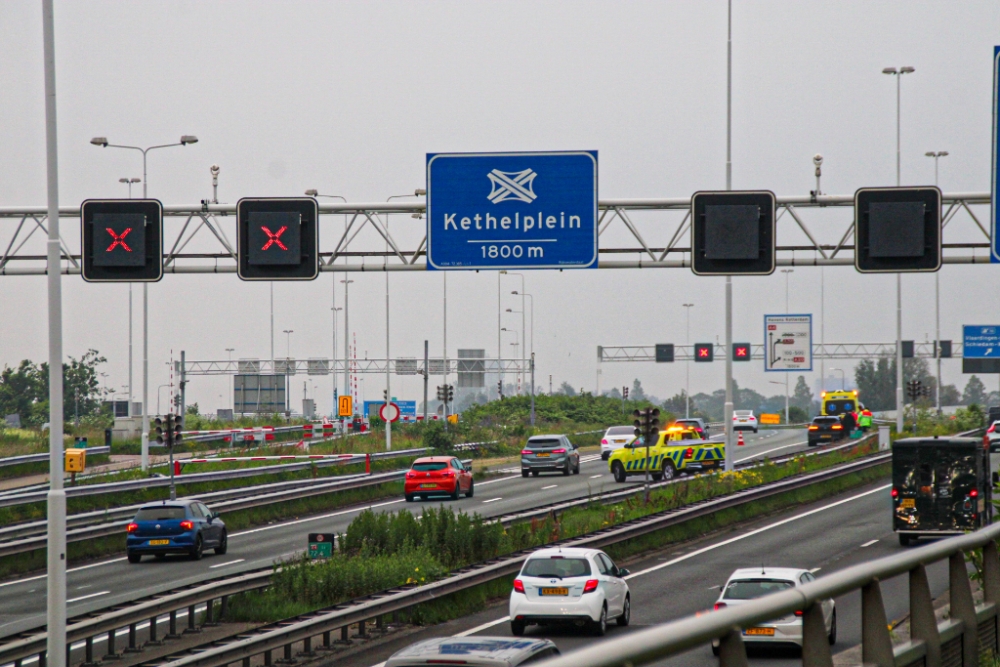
[854,186,941,273]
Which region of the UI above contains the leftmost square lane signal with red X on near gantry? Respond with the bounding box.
[80,199,163,283]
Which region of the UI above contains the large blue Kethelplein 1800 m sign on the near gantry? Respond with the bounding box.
[427,151,597,269]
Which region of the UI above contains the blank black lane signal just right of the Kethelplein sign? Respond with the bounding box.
[691,190,777,276]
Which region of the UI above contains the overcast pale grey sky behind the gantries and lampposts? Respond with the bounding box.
[0,0,1000,411]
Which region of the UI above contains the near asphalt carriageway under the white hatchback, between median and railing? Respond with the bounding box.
[338,482,932,667]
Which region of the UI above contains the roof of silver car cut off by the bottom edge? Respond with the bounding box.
[384,637,559,667]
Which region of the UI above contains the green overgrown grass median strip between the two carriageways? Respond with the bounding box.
[221,443,887,622]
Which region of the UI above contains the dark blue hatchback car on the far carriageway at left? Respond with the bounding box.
[125,500,229,563]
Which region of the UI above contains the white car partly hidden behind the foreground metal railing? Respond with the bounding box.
[712,567,837,655]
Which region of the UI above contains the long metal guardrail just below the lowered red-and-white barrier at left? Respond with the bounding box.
[0,447,429,507]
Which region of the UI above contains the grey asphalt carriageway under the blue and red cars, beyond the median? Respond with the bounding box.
[0,430,807,638]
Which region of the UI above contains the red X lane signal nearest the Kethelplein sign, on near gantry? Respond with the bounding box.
[236,197,319,280]
